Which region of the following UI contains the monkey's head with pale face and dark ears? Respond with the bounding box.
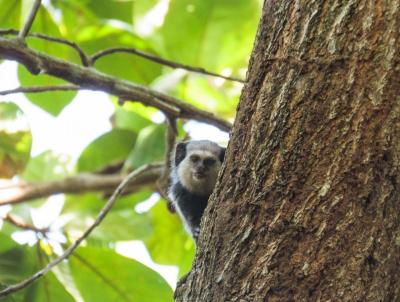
[174,140,225,195]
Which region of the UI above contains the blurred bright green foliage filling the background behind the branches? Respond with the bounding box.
[0,0,262,302]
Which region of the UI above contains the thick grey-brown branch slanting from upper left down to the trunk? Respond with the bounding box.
[0,38,232,131]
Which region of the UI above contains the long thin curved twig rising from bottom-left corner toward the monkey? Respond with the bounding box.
[0,165,156,297]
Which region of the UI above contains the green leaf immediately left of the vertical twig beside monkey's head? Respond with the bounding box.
[125,125,165,168]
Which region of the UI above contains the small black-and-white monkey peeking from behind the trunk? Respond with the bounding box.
[168,140,225,243]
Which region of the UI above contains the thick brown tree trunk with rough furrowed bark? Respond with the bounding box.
[176,0,400,302]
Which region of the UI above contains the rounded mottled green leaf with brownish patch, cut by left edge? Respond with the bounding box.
[0,103,32,178]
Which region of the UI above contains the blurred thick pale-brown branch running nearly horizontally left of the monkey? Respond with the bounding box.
[0,164,164,206]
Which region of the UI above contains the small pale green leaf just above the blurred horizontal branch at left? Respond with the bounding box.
[22,151,69,181]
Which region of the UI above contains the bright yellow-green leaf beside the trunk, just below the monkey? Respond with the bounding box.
[144,200,195,276]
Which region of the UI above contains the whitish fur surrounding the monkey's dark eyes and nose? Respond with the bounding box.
[177,150,221,195]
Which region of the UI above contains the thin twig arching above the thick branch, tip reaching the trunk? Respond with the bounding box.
[90,47,245,83]
